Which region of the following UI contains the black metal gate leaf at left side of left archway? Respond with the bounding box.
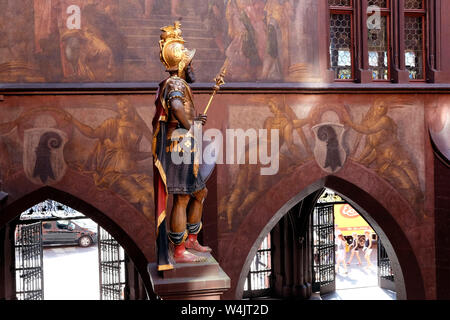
[15,222,44,300]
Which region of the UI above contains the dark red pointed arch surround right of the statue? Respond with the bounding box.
[221,161,425,299]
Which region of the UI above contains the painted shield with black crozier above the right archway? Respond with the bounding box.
[312,123,347,173]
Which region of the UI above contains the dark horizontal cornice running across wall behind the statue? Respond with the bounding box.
[0,82,450,97]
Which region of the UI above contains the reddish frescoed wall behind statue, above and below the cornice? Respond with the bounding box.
[0,0,450,299]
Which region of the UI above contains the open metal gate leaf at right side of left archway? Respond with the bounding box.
[98,226,127,300]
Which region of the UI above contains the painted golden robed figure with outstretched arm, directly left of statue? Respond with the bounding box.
[66,99,154,219]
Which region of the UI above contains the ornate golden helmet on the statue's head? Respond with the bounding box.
[159,21,195,76]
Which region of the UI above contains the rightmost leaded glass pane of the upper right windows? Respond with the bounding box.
[405,16,424,79]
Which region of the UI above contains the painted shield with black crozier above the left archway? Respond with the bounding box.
[23,128,68,185]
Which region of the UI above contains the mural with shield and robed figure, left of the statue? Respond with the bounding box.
[0,98,154,219]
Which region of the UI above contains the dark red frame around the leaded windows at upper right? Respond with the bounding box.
[326,0,432,84]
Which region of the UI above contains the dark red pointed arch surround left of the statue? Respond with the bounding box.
[0,170,155,298]
